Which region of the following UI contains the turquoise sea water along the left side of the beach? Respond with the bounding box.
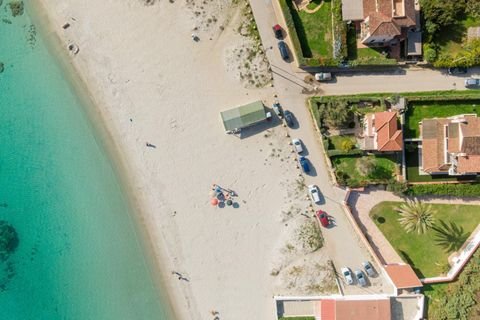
[0,1,169,320]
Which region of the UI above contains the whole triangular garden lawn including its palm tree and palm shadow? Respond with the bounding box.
[370,201,480,278]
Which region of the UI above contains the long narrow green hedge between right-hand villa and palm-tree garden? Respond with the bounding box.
[407,183,480,197]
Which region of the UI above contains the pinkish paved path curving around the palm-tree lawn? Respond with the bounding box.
[348,187,480,264]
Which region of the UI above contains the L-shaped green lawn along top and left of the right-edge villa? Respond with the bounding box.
[404,100,480,138]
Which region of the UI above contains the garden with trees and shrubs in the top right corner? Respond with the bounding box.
[420,0,480,67]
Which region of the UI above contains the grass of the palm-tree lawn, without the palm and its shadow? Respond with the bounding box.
[370,201,480,278]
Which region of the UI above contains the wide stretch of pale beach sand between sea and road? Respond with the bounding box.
[33,0,334,320]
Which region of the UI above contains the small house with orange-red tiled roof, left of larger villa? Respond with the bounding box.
[361,111,403,152]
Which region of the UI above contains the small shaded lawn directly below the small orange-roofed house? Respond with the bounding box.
[332,155,395,187]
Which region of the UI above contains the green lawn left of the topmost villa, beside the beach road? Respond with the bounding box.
[288,0,333,58]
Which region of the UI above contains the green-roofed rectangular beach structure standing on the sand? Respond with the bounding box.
[220,100,267,131]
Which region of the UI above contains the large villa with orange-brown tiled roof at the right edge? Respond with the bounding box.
[420,114,480,175]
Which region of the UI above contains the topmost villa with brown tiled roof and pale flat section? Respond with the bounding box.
[342,0,422,56]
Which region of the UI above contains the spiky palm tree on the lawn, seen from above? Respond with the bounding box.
[395,199,434,234]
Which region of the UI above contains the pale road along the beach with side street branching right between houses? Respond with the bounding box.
[251,0,480,294]
